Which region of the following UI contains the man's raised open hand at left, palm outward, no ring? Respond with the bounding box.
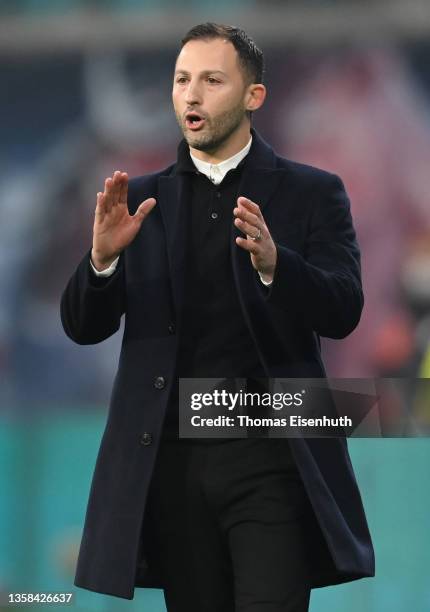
[91,170,156,270]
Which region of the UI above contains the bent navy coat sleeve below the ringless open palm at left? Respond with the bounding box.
[60,250,125,344]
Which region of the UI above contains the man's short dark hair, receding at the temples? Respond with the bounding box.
[181,21,264,117]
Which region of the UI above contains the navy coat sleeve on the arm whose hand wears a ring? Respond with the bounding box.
[266,174,364,338]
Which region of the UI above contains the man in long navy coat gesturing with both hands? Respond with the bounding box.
[61,23,374,612]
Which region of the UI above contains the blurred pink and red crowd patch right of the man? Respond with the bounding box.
[280,49,430,377]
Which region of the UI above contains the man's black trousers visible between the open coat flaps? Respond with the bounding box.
[147,438,310,612]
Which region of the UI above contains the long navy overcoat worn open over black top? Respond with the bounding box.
[61,129,374,599]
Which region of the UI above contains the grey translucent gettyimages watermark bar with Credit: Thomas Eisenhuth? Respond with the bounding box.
[179,378,430,438]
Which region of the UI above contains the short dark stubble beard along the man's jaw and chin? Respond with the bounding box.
[175,103,246,153]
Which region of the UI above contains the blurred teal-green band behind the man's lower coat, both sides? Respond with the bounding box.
[0,414,430,612]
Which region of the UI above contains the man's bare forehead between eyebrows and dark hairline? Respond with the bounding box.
[175,38,239,73]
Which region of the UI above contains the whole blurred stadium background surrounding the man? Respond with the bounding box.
[0,0,430,612]
